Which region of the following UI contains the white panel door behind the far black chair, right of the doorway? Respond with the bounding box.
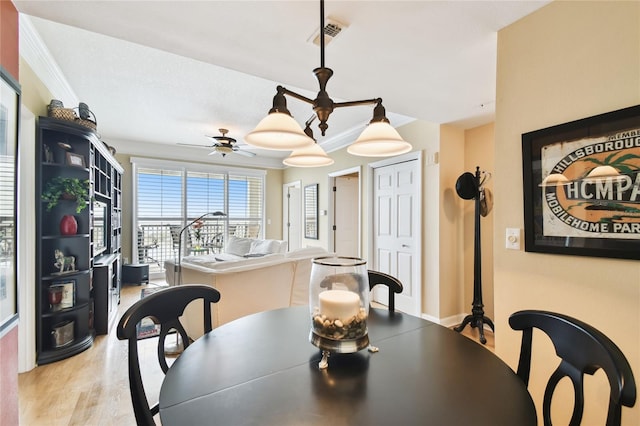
[371,160,420,315]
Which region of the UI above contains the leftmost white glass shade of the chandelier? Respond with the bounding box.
[244,112,315,151]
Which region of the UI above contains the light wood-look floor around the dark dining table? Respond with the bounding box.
[18,284,494,426]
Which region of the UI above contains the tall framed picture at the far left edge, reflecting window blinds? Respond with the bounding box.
[0,67,20,336]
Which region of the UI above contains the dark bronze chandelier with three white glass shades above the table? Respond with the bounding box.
[245,0,412,167]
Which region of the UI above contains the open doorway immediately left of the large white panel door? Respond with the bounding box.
[329,167,362,257]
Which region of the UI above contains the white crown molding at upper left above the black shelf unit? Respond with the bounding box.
[20,13,79,105]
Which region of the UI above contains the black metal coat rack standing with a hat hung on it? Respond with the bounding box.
[454,167,495,345]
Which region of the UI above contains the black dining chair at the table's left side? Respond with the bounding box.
[117,284,220,426]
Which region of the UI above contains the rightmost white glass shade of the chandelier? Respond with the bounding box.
[347,121,412,157]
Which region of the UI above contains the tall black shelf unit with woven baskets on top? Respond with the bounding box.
[35,117,123,365]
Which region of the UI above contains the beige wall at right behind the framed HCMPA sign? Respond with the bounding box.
[494,1,640,426]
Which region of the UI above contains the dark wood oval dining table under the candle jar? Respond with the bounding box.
[160,306,536,426]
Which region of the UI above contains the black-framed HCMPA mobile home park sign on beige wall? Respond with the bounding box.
[522,105,640,259]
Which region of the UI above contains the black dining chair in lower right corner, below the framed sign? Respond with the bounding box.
[509,310,636,426]
